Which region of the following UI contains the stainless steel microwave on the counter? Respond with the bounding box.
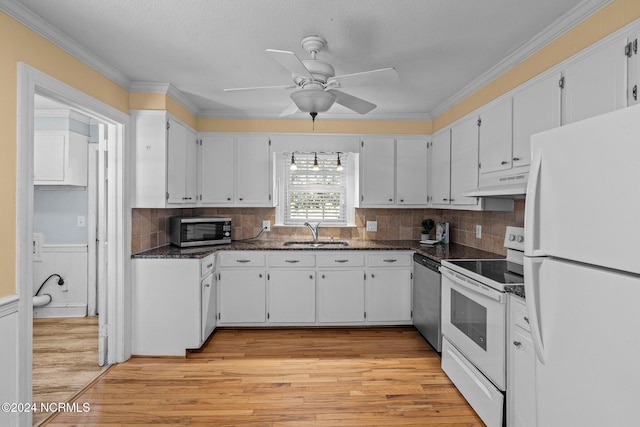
[170,216,231,248]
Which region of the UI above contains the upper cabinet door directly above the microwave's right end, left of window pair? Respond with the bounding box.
[200,136,234,204]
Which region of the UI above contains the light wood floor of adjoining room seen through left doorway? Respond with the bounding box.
[33,316,106,425]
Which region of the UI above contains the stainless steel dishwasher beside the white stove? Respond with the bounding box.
[413,253,442,353]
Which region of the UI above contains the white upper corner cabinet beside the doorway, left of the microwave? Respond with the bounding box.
[131,110,197,208]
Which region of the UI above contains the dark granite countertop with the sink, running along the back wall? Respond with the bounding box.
[132,240,504,262]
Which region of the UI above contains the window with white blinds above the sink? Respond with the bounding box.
[281,153,353,226]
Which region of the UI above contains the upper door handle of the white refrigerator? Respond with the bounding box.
[524,150,545,256]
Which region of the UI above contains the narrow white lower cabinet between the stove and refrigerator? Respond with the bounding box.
[507,295,536,427]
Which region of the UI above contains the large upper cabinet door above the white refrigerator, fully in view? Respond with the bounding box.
[563,37,627,124]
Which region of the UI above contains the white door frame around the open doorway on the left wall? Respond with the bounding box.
[16,62,131,426]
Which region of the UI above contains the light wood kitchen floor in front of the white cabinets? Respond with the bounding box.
[48,327,484,427]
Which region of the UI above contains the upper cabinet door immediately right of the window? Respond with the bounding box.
[360,138,395,206]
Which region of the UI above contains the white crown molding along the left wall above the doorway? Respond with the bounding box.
[0,0,131,90]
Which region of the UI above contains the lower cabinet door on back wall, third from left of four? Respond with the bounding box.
[318,270,364,323]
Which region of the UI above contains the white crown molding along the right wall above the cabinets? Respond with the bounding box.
[430,0,613,117]
